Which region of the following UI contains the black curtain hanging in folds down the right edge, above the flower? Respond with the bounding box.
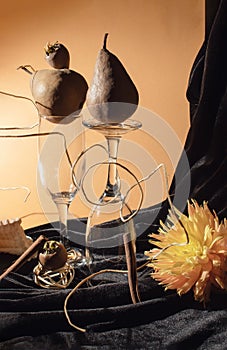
[171,1,227,219]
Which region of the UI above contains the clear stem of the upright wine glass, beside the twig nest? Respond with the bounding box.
[55,202,70,249]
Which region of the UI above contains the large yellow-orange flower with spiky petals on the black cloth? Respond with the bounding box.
[145,200,227,302]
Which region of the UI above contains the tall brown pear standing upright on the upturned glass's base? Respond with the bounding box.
[86,33,139,123]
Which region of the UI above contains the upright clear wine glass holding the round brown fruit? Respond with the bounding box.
[38,115,85,263]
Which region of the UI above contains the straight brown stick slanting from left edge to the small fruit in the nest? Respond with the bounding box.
[0,235,47,281]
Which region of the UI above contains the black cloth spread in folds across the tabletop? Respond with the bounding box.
[0,219,227,350]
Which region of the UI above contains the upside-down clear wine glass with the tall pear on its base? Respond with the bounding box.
[82,119,141,264]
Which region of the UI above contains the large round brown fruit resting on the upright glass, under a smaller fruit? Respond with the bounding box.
[31,69,88,123]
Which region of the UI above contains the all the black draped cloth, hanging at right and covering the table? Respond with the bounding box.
[0,0,227,350]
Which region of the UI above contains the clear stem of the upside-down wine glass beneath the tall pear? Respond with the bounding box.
[105,136,120,197]
